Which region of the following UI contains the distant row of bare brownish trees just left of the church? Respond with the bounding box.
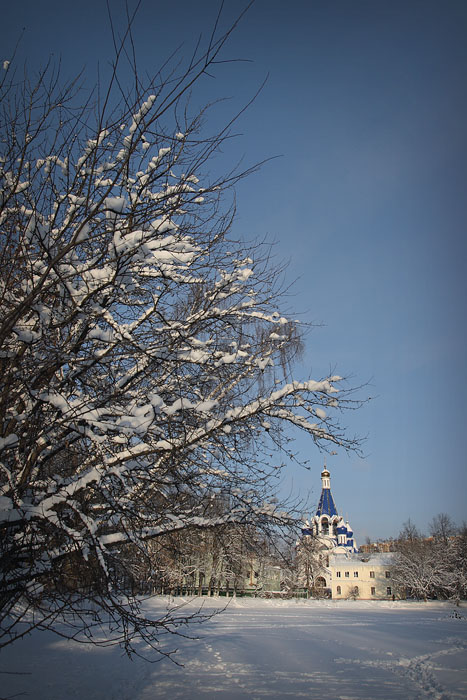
[110,494,286,596]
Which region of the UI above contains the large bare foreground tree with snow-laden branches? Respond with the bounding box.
[0,9,356,650]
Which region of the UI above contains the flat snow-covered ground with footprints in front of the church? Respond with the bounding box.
[0,598,467,700]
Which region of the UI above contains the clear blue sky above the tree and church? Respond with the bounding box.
[0,0,467,543]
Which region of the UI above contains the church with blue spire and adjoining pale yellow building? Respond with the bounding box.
[298,466,396,600]
